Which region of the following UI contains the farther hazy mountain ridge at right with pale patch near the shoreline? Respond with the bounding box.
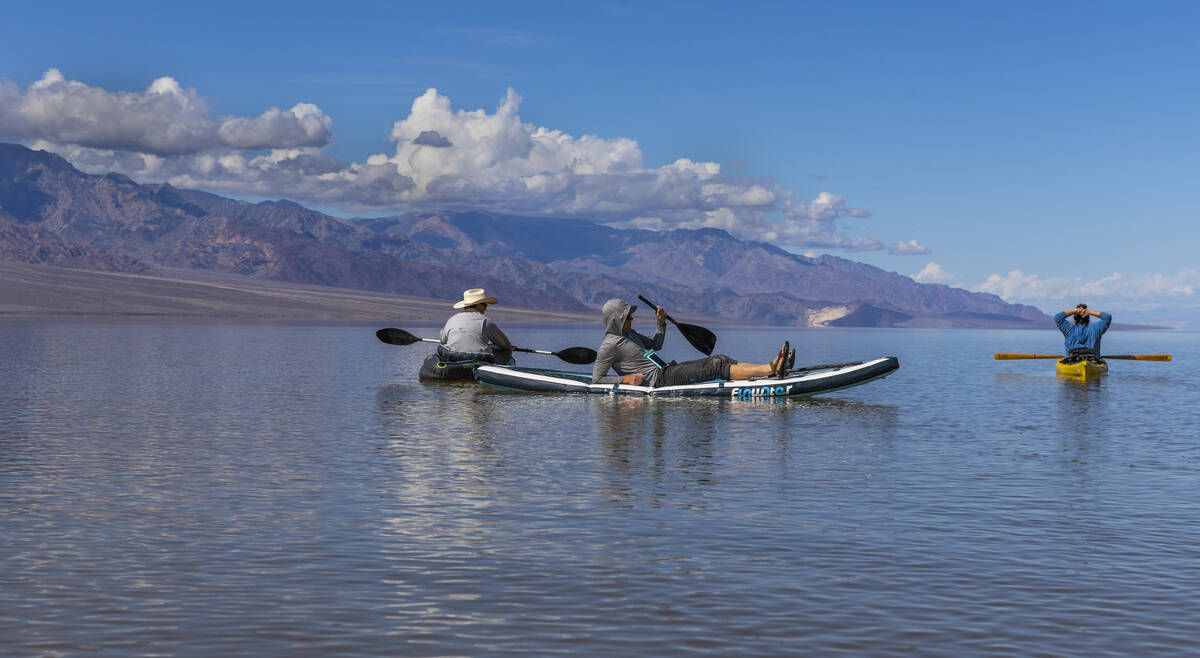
[355,211,1048,327]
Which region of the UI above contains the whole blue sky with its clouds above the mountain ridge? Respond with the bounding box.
[0,1,1200,325]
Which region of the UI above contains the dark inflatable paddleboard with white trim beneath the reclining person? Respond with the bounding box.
[475,357,900,400]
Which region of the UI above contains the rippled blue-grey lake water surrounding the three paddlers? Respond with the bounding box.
[0,321,1200,656]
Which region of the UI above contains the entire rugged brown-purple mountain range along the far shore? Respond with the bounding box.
[0,144,1048,327]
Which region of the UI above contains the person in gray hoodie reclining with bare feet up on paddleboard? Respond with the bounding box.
[592,299,796,388]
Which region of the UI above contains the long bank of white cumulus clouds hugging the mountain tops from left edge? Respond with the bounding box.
[0,70,902,253]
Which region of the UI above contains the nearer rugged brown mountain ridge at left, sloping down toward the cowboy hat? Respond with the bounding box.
[0,144,583,310]
